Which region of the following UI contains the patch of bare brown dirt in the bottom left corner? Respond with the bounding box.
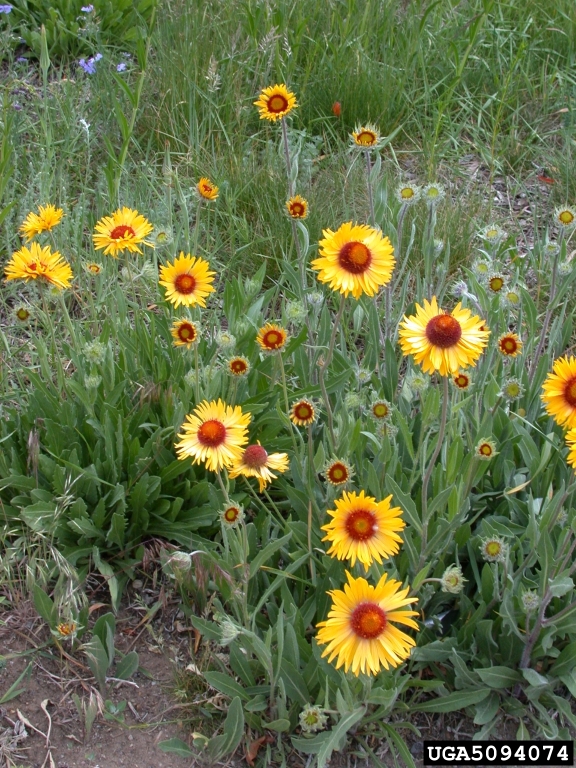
[0,605,191,768]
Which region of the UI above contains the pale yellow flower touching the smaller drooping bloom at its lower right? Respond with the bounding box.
[176,400,252,472]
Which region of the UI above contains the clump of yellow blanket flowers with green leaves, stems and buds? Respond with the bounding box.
[0,73,576,768]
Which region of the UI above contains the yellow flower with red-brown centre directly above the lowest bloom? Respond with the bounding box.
[322,491,406,571]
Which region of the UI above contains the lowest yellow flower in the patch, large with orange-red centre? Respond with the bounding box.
[317,572,418,676]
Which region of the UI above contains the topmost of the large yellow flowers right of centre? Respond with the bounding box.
[312,221,396,299]
